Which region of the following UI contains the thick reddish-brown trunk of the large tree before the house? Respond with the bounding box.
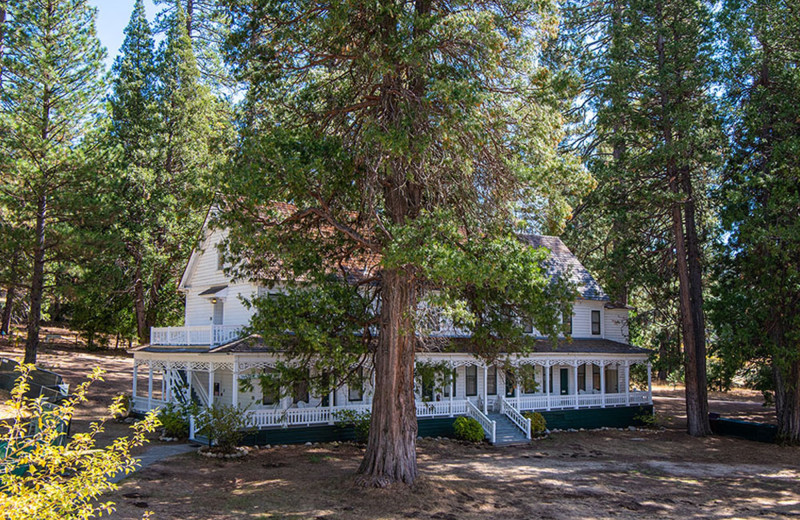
[358,270,417,487]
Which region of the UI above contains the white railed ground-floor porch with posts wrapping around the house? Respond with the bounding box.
[132,354,652,439]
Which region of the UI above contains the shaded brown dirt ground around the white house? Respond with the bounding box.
[0,336,800,520]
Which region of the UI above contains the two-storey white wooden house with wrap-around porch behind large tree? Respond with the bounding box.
[133,221,652,444]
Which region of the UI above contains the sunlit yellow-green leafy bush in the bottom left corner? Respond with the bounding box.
[0,365,158,520]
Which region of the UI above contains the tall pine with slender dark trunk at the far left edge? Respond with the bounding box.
[0,0,104,363]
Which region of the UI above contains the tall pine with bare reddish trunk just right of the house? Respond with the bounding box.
[560,0,722,435]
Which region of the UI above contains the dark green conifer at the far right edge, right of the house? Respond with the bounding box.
[714,0,800,444]
